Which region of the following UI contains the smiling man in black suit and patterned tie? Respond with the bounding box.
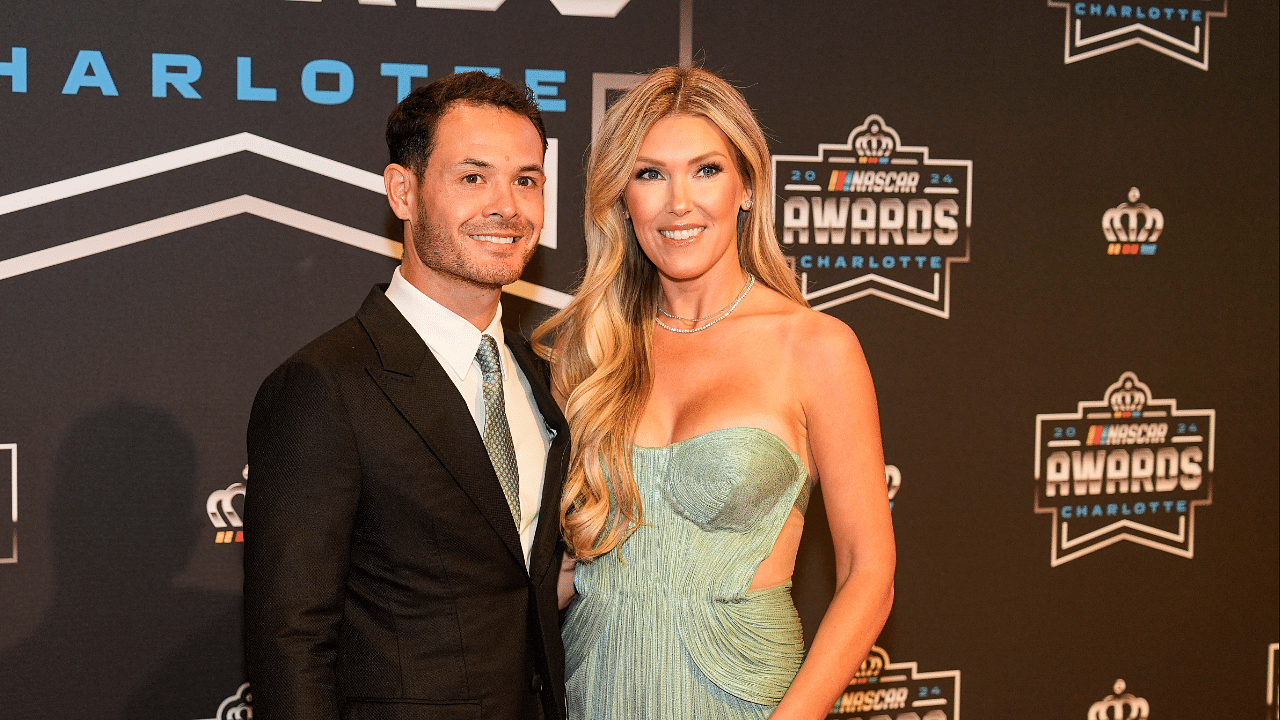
[244,73,568,720]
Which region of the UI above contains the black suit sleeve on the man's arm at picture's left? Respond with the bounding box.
[244,360,360,720]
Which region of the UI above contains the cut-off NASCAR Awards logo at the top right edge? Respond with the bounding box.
[1048,0,1226,70]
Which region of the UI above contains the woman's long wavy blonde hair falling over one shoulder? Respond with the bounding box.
[534,68,808,561]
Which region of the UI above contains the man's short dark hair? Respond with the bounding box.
[387,70,547,178]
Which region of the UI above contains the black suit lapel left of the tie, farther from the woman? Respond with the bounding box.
[356,286,524,568]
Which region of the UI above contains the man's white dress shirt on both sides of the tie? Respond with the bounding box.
[387,268,550,568]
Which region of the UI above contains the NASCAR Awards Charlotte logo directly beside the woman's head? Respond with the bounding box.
[773,115,973,318]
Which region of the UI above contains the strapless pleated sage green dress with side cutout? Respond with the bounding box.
[563,428,810,720]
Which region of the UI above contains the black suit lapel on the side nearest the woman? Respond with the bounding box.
[507,338,570,582]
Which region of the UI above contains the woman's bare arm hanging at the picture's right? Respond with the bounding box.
[772,315,896,720]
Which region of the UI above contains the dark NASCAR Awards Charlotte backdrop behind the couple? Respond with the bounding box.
[0,0,1280,720]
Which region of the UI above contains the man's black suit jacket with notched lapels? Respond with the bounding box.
[244,286,570,720]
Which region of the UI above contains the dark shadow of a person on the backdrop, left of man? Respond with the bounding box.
[0,402,239,720]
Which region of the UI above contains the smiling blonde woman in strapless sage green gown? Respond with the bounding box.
[535,68,895,720]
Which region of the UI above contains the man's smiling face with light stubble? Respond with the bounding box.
[412,104,547,288]
